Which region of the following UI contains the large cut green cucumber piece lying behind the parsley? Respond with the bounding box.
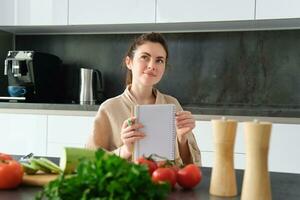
[59,147,95,174]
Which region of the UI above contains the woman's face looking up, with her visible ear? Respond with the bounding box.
[126,42,166,86]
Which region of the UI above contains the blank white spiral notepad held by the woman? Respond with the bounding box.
[134,104,176,160]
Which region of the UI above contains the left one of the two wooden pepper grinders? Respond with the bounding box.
[209,118,237,197]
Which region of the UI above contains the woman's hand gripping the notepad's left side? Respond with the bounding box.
[120,117,145,159]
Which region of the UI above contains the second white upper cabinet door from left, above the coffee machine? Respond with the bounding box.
[15,0,68,26]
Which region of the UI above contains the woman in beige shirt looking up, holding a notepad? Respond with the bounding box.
[86,33,200,165]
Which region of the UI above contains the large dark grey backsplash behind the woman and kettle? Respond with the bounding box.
[13,30,300,114]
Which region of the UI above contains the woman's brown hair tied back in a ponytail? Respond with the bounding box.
[123,32,169,85]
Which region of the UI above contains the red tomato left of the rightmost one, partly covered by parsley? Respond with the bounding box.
[152,167,176,188]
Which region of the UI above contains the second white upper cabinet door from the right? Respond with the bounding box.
[156,0,255,23]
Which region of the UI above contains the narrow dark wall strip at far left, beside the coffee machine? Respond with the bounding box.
[0,30,13,96]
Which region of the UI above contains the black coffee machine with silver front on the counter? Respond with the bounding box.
[4,51,62,103]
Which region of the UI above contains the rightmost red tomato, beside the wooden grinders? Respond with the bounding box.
[177,164,202,189]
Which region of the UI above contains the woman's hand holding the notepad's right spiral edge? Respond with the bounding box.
[176,111,196,142]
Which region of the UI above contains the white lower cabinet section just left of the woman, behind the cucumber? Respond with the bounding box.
[47,115,94,156]
